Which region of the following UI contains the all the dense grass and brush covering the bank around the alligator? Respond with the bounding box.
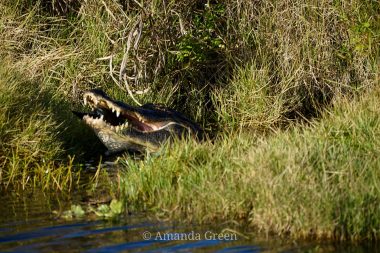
[0,0,380,239]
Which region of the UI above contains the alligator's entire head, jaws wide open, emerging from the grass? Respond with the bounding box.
[74,89,202,153]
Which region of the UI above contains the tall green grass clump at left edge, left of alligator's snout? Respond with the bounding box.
[0,60,75,190]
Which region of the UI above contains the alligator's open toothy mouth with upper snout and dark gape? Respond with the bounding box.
[74,90,170,133]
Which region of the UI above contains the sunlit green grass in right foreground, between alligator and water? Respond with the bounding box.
[123,89,380,240]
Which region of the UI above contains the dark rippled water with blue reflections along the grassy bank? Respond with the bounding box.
[0,192,378,253]
